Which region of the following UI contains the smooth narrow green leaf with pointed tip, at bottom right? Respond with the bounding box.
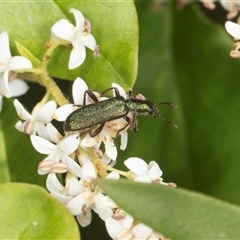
[99,180,240,239]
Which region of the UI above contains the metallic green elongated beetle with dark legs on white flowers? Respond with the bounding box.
[64,87,177,137]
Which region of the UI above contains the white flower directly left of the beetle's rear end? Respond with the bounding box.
[14,99,57,139]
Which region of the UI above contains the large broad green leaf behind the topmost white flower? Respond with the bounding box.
[0,0,138,90]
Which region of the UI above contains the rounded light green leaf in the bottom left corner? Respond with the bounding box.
[0,183,79,239]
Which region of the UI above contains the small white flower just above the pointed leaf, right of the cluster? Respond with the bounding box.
[124,157,162,182]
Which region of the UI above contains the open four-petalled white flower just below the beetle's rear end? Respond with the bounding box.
[30,134,81,177]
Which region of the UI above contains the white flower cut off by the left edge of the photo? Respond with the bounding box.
[0,31,32,98]
